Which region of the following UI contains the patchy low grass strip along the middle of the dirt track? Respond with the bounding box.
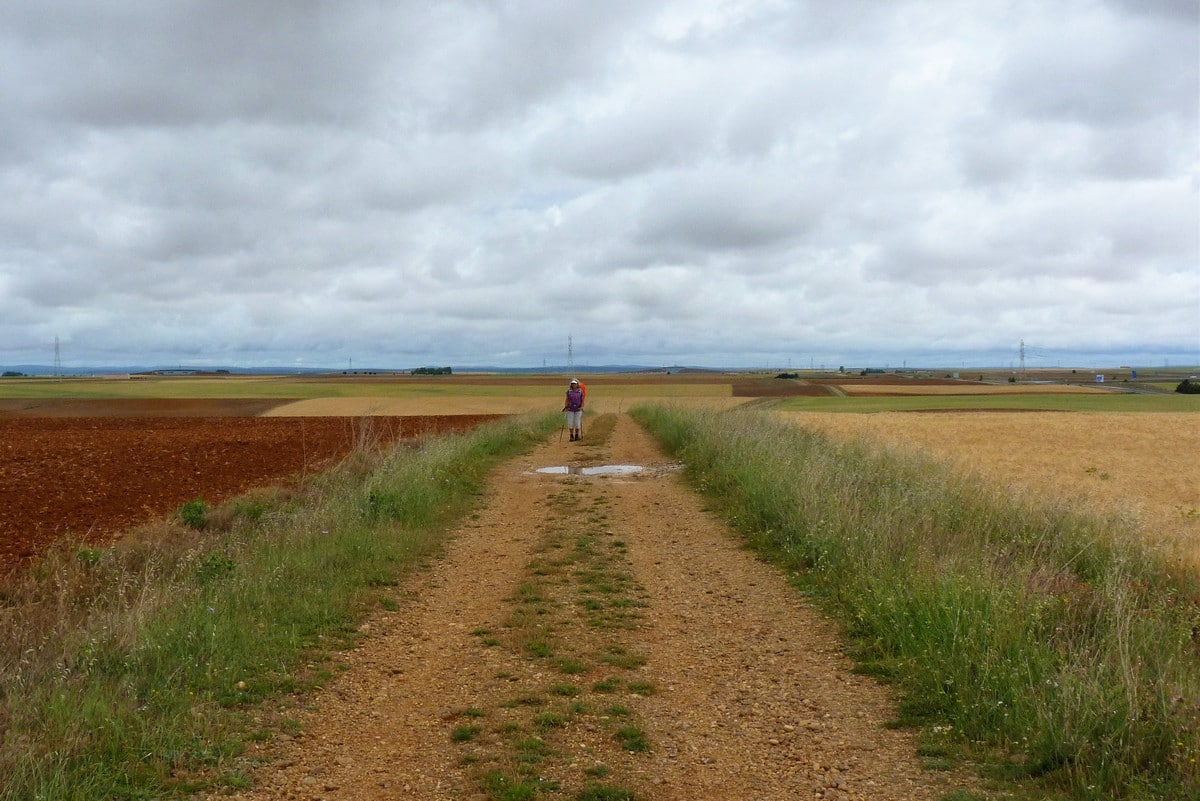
[448,443,655,801]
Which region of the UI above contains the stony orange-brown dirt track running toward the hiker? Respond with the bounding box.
[222,416,964,801]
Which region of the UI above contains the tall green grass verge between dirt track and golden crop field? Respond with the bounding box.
[635,406,1200,799]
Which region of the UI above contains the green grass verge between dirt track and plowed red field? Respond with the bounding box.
[0,415,559,801]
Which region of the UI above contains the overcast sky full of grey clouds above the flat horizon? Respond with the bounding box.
[0,0,1200,369]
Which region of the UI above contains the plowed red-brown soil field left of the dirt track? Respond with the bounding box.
[0,402,496,572]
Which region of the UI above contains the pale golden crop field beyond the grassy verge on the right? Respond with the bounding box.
[779,412,1200,567]
